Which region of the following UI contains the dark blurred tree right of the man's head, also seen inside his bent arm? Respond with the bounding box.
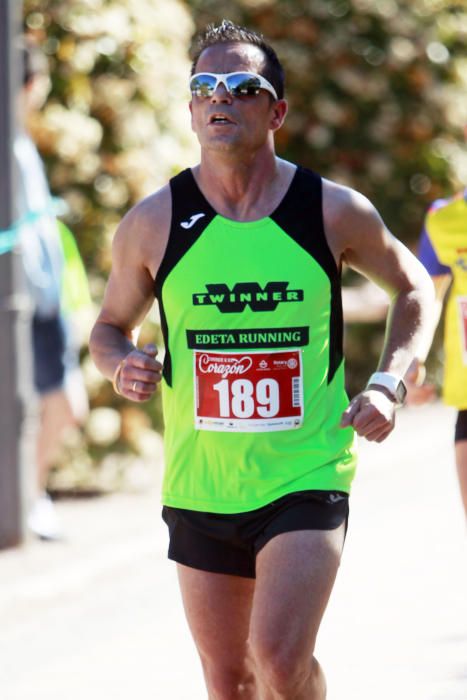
[188,0,467,394]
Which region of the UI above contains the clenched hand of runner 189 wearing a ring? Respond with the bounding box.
[117,343,162,402]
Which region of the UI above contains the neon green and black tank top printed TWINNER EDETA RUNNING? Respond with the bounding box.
[155,168,356,513]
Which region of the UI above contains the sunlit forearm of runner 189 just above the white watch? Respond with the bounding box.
[378,278,435,377]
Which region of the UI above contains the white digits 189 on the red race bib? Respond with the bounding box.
[213,378,279,418]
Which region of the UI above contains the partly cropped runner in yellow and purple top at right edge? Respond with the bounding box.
[406,174,467,517]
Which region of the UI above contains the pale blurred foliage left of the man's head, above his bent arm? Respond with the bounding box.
[24,0,197,284]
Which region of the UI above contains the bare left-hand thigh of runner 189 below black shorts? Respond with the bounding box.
[177,564,255,667]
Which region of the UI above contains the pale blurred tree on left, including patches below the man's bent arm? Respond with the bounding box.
[24,0,198,488]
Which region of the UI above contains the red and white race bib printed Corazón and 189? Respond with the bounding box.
[193,350,303,432]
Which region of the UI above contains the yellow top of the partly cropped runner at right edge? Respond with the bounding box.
[425,194,467,410]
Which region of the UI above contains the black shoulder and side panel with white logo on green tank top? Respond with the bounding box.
[154,169,216,386]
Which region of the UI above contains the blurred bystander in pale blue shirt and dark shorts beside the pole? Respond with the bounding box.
[14,43,90,540]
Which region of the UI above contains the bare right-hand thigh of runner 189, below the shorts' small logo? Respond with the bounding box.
[250,524,345,658]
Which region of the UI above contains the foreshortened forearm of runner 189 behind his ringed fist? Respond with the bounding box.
[89,321,136,380]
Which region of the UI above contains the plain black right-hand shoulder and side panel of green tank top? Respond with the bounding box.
[271,167,343,384]
